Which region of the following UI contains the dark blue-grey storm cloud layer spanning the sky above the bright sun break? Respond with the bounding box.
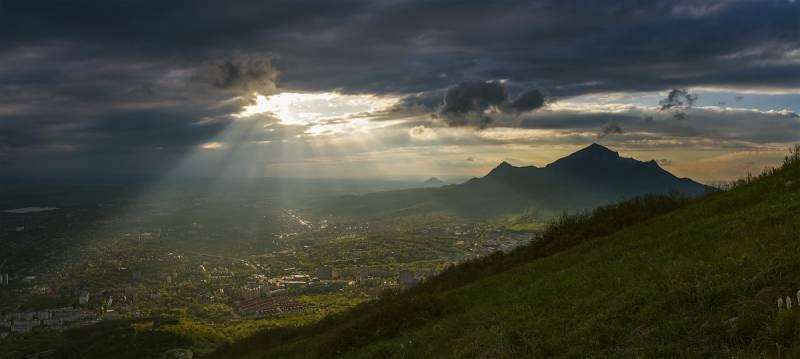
[0,0,800,175]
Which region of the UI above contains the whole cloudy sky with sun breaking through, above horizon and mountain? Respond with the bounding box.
[0,0,800,183]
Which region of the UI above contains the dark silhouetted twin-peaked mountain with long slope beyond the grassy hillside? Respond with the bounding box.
[319,144,708,217]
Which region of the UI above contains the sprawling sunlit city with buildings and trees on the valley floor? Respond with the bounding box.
[0,187,538,356]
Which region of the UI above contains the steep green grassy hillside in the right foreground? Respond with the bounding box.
[218,151,800,358]
